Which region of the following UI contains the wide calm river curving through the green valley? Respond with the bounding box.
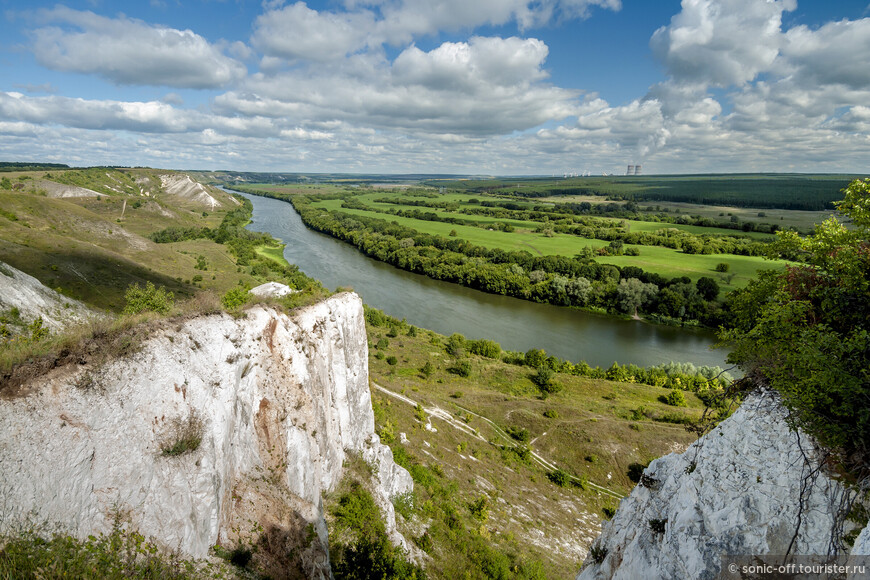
[238,195,725,367]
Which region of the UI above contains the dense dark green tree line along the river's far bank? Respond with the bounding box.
[288,192,724,326]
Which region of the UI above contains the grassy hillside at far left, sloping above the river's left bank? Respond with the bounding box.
[0,168,306,310]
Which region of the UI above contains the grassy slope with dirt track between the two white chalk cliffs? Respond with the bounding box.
[368,314,716,579]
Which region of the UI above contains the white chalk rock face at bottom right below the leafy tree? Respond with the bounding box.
[577,392,870,580]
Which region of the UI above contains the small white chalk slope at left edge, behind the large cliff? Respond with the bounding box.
[0,262,96,331]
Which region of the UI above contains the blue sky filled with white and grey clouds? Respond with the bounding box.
[0,0,870,175]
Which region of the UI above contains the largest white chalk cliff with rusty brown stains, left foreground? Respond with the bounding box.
[0,293,412,578]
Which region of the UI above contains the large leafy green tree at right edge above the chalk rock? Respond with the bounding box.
[720,179,870,475]
